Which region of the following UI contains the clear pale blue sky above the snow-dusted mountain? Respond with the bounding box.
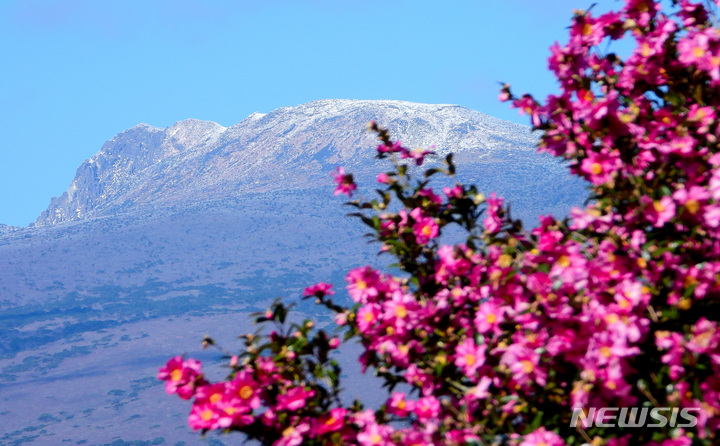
[0,0,621,226]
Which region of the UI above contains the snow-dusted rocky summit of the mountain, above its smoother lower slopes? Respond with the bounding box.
[37,100,562,225]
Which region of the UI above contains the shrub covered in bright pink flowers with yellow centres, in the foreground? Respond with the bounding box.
[159,0,720,446]
